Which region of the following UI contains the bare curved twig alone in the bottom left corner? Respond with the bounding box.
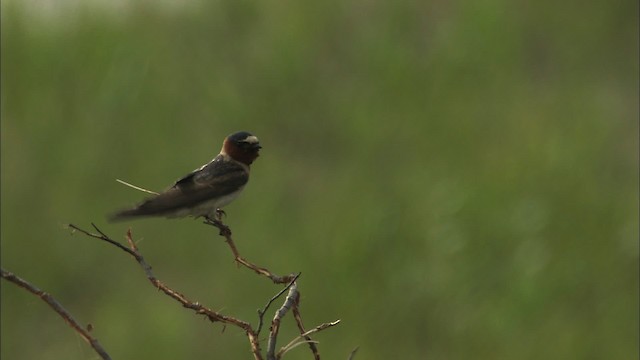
[0,269,111,360]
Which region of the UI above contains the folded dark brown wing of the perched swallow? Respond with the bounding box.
[116,156,249,218]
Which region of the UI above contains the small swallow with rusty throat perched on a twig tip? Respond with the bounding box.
[109,131,262,222]
